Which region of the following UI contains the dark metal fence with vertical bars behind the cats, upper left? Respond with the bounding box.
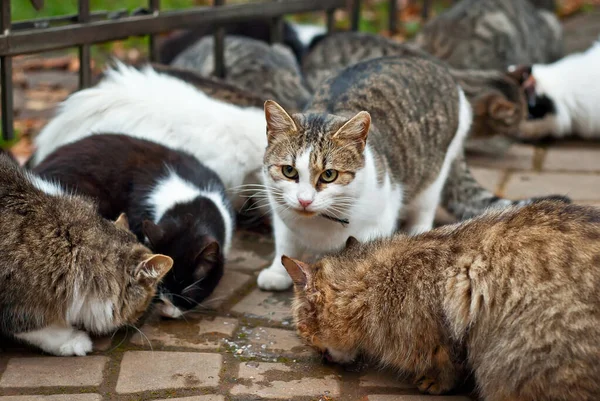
[0,0,431,140]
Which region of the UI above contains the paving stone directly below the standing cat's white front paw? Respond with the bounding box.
[232,289,294,324]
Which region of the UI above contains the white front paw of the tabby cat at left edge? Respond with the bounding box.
[15,325,92,356]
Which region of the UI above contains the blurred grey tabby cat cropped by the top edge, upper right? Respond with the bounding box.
[415,0,563,71]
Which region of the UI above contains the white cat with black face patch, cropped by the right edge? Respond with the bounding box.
[510,41,600,140]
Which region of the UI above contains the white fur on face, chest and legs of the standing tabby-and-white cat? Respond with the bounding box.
[258,88,472,290]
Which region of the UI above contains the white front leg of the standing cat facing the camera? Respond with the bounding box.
[258,213,303,291]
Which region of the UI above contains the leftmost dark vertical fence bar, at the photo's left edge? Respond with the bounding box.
[0,0,15,140]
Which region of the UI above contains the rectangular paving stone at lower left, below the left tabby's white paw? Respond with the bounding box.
[0,356,108,387]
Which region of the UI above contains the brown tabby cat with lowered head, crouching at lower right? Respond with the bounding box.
[283,201,600,401]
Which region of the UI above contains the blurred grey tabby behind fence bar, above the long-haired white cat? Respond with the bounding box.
[171,36,310,111]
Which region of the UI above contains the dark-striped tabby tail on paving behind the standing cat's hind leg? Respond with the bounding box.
[442,155,571,220]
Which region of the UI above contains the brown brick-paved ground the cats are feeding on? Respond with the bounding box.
[0,7,600,401]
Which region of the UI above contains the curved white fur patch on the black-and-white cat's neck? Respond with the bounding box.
[148,170,234,255]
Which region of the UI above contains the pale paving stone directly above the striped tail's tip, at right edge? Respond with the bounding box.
[504,173,600,201]
